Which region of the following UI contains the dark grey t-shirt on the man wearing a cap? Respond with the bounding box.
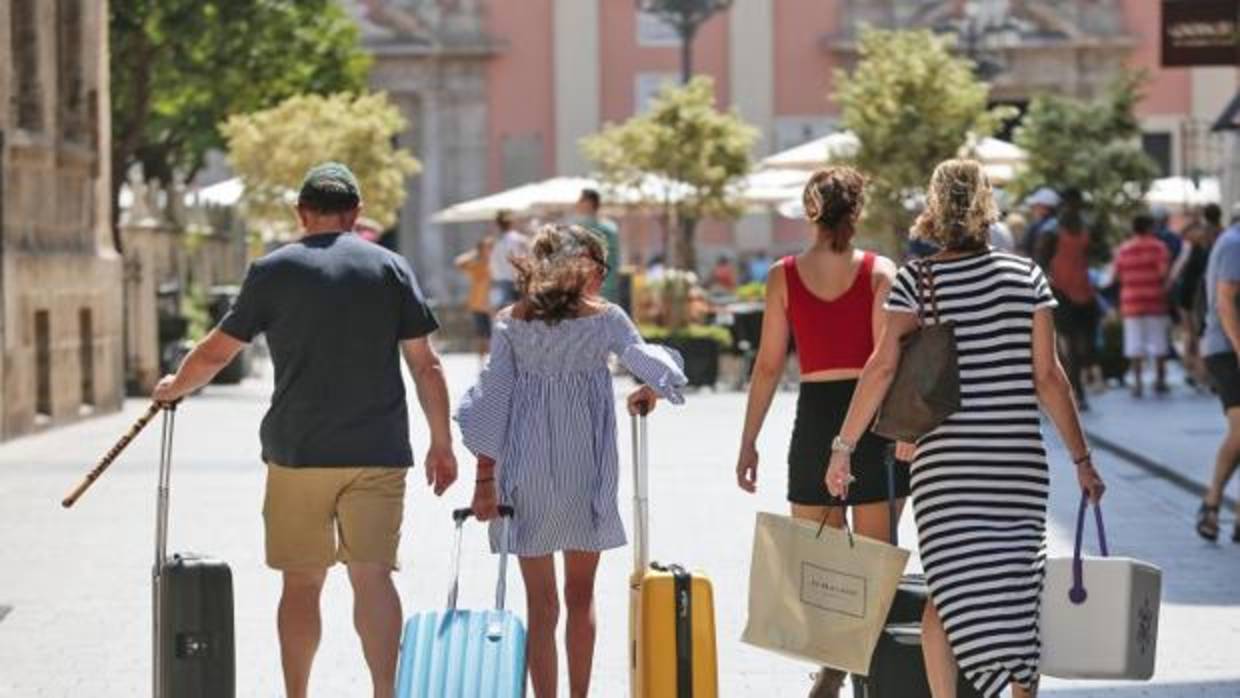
[219,233,438,467]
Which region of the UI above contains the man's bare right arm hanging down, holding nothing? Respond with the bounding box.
[401,336,456,495]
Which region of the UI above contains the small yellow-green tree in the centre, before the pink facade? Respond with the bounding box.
[582,77,758,269]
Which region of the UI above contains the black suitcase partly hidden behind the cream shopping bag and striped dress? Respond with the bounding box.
[853,446,981,698]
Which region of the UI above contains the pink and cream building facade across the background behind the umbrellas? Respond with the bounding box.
[341,0,1240,295]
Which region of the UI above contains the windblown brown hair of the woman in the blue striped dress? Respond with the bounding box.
[511,223,608,325]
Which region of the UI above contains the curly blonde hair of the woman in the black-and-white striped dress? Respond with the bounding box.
[913,160,999,249]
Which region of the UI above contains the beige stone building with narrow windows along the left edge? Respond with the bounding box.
[0,0,123,439]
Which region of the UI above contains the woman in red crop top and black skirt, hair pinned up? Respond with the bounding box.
[737,167,909,698]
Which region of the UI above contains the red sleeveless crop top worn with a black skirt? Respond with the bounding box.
[782,252,874,374]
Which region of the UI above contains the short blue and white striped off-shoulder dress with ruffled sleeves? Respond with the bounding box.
[456,305,687,557]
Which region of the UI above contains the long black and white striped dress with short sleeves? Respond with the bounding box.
[887,250,1055,697]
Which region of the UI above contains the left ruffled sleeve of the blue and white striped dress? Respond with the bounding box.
[456,320,517,461]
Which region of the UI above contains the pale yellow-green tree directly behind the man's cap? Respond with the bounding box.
[221,93,419,236]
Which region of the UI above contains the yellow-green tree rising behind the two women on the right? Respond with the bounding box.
[835,29,1012,251]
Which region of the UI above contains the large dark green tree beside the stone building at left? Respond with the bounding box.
[109,0,370,247]
